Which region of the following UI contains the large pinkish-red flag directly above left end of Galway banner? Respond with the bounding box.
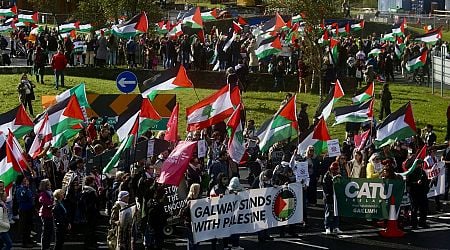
[158,141,197,186]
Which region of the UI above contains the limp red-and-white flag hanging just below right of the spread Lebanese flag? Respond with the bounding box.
[227,103,248,164]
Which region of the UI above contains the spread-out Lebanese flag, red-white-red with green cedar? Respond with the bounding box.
[186,85,241,132]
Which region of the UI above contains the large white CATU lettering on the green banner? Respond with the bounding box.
[345,181,394,200]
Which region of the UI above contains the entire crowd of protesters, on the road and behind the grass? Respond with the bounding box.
[0,15,450,249]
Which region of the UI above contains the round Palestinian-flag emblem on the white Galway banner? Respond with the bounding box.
[272,188,297,221]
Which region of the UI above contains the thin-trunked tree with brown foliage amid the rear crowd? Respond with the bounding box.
[266,0,341,97]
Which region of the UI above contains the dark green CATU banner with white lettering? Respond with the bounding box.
[333,177,405,219]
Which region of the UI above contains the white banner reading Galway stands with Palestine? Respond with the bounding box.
[190,183,303,242]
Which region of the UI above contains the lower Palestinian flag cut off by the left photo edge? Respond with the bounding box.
[0,131,28,198]
